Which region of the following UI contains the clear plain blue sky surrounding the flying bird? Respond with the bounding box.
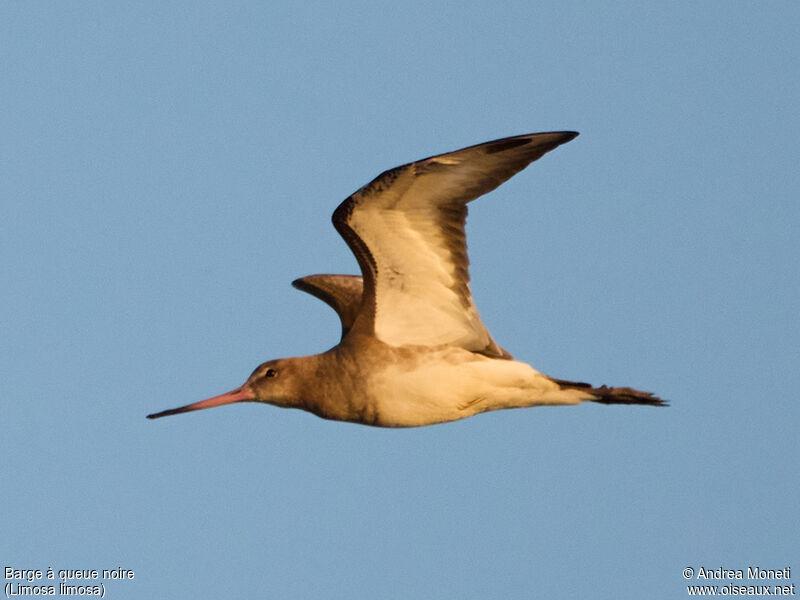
[0,0,800,600]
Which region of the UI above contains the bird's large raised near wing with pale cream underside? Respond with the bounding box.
[333,132,578,357]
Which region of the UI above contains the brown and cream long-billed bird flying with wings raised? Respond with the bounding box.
[147,131,667,428]
